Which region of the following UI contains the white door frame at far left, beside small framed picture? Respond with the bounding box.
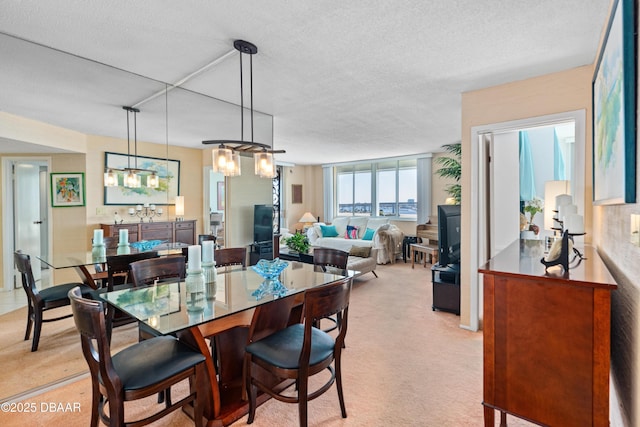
[0,156,53,292]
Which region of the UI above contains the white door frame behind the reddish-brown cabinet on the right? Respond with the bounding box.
[461,109,587,331]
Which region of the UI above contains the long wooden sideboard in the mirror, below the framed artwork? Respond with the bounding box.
[100,219,197,245]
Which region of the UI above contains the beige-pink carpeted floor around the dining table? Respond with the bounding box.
[0,263,531,427]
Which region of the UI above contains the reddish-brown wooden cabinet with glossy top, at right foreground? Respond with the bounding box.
[479,240,617,427]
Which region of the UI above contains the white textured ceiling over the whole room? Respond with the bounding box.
[0,0,610,164]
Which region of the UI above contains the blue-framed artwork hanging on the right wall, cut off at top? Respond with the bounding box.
[592,0,636,205]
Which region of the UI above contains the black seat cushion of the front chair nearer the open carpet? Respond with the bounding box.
[246,323,335,369]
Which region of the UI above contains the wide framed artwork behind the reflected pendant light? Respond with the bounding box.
[104,152,180,205]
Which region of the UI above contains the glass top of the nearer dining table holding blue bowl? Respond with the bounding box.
[100,262,356,335]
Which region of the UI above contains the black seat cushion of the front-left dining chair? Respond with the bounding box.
[106,336,205,390]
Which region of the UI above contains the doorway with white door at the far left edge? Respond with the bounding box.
[2,157,51,291]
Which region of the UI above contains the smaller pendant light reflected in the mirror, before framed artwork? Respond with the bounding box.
[104,106,160,188]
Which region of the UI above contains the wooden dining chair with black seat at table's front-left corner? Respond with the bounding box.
[68,287,207,427]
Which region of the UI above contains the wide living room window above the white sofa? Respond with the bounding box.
[334,159,418,219]
